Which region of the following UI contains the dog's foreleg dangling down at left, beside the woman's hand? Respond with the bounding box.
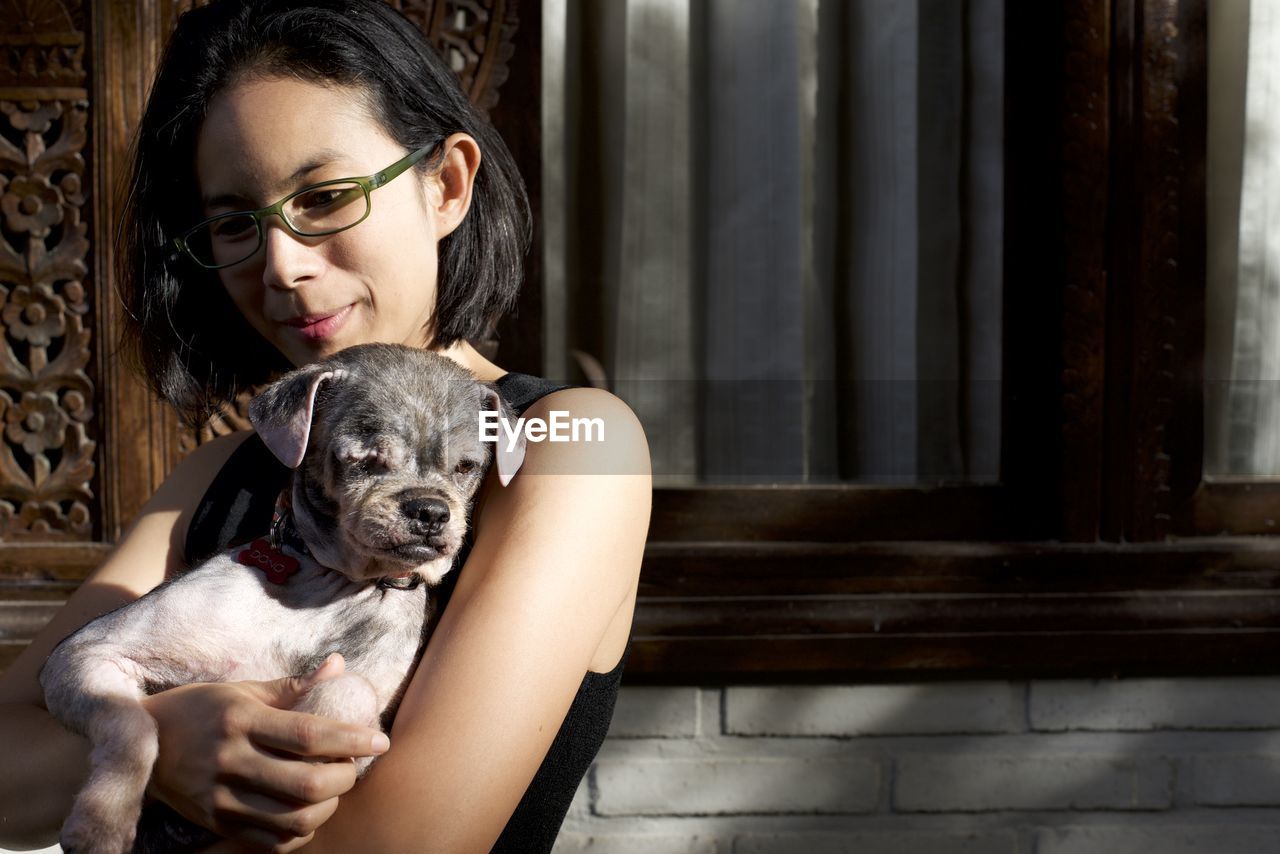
[47,657,160,854]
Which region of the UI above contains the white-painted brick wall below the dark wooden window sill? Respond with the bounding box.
[556,677,1280,854]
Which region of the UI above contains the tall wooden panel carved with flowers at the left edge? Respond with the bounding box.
[0,0,99,542]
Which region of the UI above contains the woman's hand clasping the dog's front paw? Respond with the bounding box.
[143,656,389,853]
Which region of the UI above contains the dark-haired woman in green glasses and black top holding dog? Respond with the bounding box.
[0,0,650,851]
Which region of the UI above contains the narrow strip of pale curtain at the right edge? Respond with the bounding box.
[1204,0,1280,476]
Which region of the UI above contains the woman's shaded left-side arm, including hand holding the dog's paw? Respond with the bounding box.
[0,434,383,848]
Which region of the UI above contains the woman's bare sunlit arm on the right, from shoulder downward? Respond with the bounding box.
[245,389,652,853]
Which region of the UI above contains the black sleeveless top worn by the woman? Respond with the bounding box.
[186,373,631,853]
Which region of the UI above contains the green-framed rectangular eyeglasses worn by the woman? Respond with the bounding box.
[172,145,435,270]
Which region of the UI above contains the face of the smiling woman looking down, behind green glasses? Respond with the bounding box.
[196,77,456,365]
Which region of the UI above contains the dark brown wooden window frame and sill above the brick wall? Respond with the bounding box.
[627,0,1280,684]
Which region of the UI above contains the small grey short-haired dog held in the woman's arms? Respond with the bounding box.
[40,344,525,854]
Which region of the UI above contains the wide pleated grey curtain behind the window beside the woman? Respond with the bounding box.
[543,0,1004,484]
